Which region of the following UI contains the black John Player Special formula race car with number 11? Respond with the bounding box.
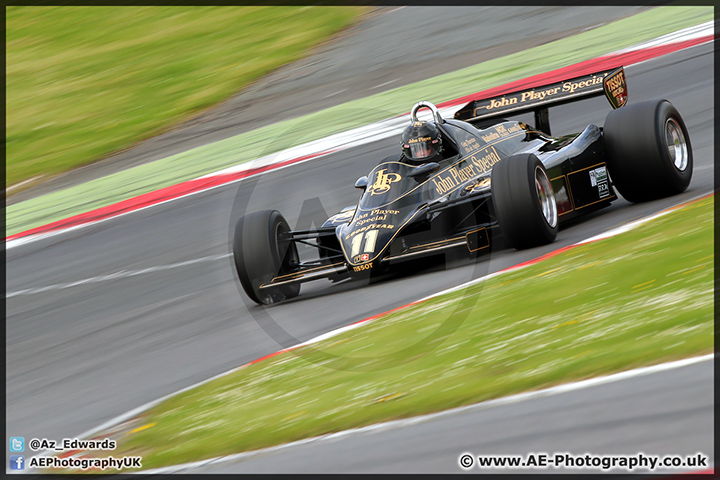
[233,67,693,304]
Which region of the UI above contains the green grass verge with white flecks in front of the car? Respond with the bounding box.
[101,197,714,468]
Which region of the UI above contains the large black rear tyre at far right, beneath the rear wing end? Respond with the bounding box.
[603,100,693,202]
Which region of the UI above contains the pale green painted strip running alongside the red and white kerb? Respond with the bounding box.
[6,7,713,235]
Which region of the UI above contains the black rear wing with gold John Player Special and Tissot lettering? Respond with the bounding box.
[455,67,627,135]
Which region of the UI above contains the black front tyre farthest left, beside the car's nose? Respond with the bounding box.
[233,210,300,305]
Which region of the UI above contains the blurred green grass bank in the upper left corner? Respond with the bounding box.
[6,6,365,186]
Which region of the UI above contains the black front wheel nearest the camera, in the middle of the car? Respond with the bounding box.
[491,154,558,249]
